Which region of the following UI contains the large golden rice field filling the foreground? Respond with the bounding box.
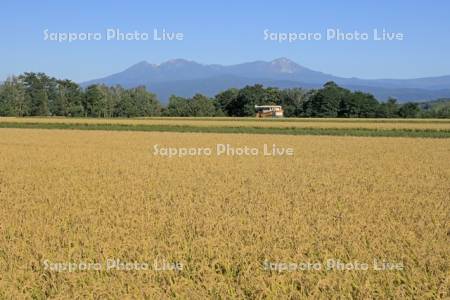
[0,127,450,299]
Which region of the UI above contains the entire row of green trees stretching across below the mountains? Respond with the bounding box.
[0,73,450,118]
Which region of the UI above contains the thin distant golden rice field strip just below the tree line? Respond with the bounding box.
[0,117,450,130]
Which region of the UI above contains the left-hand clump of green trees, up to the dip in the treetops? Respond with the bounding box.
[0,73,162,118]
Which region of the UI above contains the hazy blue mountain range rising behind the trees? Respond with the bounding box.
[81,58,450,103]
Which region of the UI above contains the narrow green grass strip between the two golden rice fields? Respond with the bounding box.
[0,122,450,138]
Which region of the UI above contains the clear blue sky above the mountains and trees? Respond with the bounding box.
[0,0,450,81]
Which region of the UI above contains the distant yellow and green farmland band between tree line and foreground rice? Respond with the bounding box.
[0,117,450,138]
